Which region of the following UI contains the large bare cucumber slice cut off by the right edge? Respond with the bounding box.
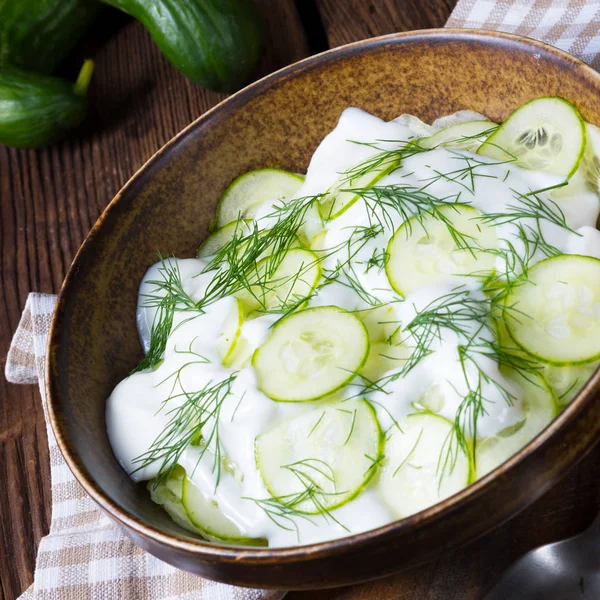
[504,254,600,366]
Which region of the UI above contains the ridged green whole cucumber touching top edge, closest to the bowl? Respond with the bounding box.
[102,0,262,92]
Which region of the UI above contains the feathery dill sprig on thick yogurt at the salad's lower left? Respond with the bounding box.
[133,366,237,488]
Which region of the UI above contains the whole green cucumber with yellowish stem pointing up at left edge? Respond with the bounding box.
[0,60,94,148]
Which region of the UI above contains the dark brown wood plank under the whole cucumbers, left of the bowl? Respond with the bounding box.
[0,0,309,600]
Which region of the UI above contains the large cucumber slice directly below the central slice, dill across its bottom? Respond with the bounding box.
[255,400,383,514]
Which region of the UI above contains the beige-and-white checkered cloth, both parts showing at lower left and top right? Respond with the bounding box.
[6,0,600,600]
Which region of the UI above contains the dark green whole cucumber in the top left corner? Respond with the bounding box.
[0,0,100,74]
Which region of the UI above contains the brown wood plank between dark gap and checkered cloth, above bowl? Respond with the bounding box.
[316,0,457,47]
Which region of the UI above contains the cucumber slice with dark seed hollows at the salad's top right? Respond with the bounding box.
[477,97,585,179]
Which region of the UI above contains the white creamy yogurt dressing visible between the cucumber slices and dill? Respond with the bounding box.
[106,108,600,546]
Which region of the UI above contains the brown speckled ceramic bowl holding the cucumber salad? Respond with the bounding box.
[46,30,600,589]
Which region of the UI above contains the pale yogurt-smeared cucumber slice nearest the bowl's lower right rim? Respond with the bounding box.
[379,413,470,519]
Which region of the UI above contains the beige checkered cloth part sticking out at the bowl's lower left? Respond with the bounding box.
[6,294,284,600]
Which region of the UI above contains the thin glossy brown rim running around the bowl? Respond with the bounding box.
[45,28,600,564]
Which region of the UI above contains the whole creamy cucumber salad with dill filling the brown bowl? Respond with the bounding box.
[106,97,600,546]
